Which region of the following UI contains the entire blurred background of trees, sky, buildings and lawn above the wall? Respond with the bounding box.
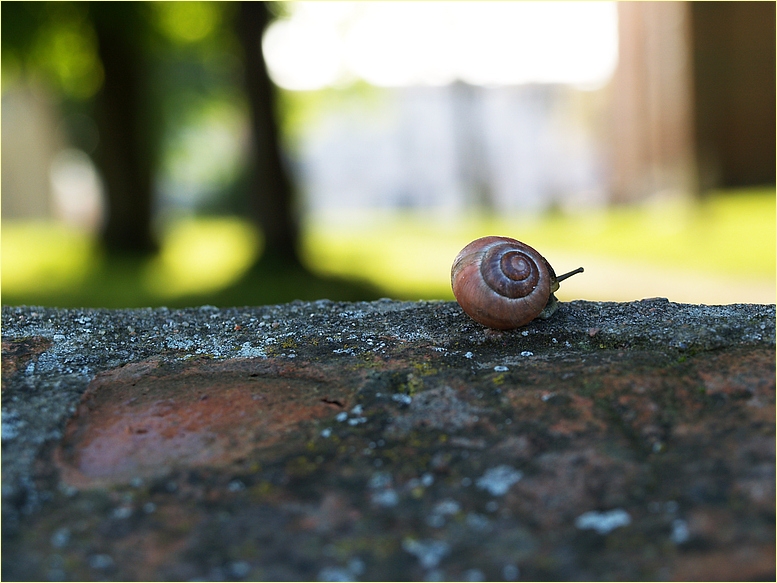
[0,2,776,307]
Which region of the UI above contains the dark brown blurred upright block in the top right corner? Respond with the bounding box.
[688,2,777,190]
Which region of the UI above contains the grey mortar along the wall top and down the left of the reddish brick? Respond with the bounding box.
[2,298,775,523]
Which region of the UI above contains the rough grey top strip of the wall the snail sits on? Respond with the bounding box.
[2,298,775,375]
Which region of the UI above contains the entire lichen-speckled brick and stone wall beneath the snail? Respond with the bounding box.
[2,299,775,581]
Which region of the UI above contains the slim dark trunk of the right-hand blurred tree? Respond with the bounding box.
[236,2,301,267]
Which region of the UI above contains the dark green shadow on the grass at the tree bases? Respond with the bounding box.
[2,256,386,308]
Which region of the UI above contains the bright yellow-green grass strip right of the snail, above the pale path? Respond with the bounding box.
[510,191,775,278]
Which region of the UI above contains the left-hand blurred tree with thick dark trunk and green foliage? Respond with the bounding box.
[1,2,159,254]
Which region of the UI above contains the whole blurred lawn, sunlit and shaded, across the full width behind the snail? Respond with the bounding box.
[2,190,777,307]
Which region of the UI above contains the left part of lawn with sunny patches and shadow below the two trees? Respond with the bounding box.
[2,218,381,308]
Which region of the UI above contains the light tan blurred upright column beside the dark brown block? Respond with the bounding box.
[611,2,697,203]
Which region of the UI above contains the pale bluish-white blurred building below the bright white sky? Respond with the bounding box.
[299,83,606,210]
